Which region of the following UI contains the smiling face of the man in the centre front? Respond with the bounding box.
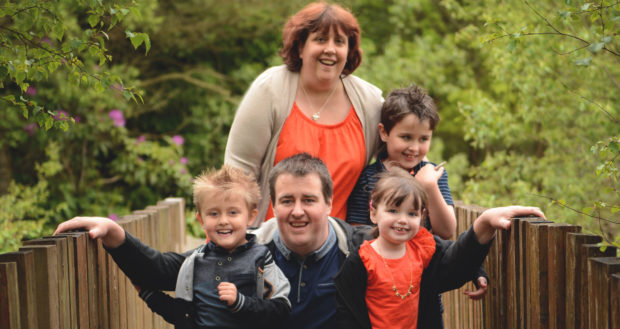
[273,173,332,256]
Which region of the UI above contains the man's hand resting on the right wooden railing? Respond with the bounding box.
[473,206,545,244]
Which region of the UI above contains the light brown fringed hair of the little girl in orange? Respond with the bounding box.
[370,167,428,235]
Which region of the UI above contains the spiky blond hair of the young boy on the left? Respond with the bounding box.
[194,165,260,211]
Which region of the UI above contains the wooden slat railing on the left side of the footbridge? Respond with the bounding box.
[0,198,185,329]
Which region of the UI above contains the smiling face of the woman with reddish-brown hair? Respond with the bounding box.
[299,26,349,82]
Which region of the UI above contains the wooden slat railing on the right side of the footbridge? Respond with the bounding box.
[443,203,620,329]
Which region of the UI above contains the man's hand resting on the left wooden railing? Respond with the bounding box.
[54,217,125,249]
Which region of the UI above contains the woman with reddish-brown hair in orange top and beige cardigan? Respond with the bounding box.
[225,2,383,226]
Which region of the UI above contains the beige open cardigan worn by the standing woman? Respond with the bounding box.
[224,65,383,226]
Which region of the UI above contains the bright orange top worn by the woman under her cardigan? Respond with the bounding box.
[266,103,366,220]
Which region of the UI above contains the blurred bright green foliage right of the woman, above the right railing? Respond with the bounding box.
[354,0,620,243]
